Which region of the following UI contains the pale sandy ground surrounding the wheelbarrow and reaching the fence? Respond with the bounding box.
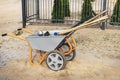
[0,0,120,80]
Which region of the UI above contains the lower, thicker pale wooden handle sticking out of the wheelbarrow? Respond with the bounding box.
[58,16,108,35]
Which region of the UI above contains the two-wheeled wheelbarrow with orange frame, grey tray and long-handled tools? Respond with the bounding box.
[2,11,108,71]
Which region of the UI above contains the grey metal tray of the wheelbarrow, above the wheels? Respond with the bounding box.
[26,31,66,52]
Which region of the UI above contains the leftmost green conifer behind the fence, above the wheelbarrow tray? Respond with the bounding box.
[52,0,65,23]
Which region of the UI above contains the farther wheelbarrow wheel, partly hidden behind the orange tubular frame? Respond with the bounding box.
[61,43,76,61]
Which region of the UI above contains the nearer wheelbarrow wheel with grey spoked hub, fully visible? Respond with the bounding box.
[46,51,66,71]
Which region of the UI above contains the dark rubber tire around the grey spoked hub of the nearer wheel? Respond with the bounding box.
[46,50,66,71]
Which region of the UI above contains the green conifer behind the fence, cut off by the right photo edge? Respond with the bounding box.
[110,0,120,25]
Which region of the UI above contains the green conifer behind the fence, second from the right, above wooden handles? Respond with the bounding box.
[81,0,93,22]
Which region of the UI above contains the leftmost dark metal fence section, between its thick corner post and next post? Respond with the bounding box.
[22,0,39,28]
